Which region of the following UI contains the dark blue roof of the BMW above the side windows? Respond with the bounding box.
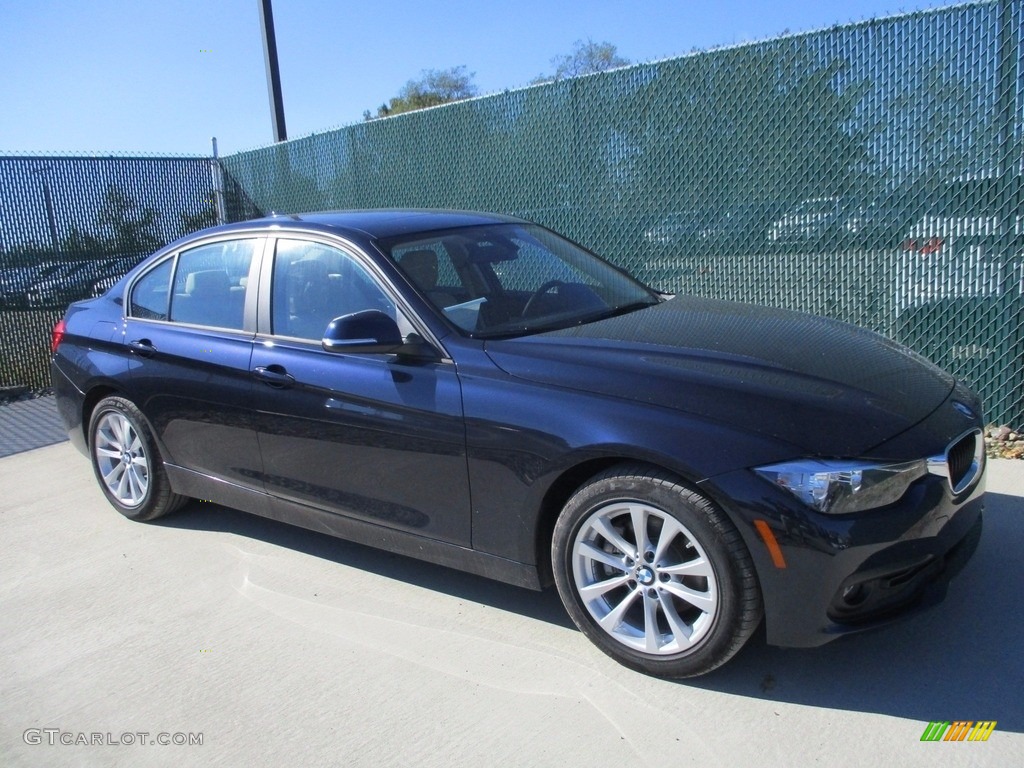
[200,208,523,240]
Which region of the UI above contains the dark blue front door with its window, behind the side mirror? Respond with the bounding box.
[251,236,470,546]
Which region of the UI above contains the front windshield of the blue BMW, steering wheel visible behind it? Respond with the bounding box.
[382,224,660,338]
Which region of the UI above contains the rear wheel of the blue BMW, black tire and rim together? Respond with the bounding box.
[89,397,187,521]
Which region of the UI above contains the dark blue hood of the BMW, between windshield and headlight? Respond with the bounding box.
[485,296,955,457]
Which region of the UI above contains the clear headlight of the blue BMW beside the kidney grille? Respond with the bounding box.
[754,459,928,515]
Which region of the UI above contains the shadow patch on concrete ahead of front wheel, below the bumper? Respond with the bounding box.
[686,493,1024,732]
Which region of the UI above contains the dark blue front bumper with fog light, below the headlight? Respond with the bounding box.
[708,456,984,647]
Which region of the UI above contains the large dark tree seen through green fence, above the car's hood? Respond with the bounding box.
[616,38,877,218]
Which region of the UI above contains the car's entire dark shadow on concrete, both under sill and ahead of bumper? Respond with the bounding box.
[156,493,1024,732]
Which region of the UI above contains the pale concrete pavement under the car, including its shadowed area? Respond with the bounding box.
[0,442,1024,768]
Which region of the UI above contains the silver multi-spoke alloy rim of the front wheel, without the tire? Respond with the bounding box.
[572,501,719,655]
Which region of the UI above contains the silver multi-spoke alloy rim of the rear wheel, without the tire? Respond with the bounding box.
[92,411,150,507]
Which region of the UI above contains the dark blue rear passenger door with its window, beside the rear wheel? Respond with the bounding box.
[124,237,266,489]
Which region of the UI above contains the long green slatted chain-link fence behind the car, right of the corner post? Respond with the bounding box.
[223,0,1024,423]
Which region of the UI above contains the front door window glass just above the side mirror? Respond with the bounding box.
[270,239,398,341]
